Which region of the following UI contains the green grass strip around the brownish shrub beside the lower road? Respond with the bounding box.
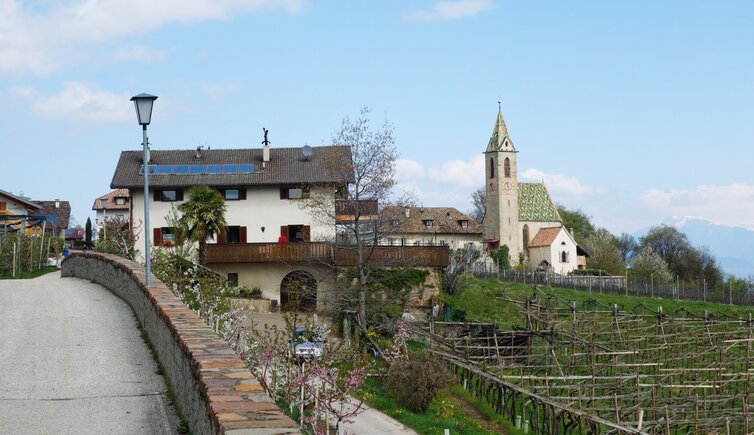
[360,377,520,435]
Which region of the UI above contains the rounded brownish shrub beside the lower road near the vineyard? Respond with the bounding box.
[385,352,452,413]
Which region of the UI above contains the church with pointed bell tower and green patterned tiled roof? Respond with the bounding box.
[483,110,586,275]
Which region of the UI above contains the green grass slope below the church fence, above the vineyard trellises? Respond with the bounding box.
[442,277,754,330]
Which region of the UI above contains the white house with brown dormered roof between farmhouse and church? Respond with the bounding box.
[381,207,482,249]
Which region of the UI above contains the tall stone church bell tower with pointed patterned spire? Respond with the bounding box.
[483,101,519,264]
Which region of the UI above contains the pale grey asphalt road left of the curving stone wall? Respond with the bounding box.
[0,272,176,434]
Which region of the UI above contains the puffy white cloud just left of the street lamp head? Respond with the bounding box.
[10,82,134,123]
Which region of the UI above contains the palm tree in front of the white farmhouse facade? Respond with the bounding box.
[178,186,226,265]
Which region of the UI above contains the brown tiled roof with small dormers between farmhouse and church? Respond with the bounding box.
[381,206,482,235]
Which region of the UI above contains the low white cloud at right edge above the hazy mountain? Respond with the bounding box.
[640,184,754,230]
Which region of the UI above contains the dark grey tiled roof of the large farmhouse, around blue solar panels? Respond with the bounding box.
[110,146,353,189]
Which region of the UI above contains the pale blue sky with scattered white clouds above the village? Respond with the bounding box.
[0,0,754,242]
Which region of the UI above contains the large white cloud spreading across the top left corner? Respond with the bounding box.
[0,0,307,75]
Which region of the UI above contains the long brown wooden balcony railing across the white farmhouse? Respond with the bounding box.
[207,242,450,267]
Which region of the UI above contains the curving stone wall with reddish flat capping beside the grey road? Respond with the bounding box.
[62,253,299,435]
